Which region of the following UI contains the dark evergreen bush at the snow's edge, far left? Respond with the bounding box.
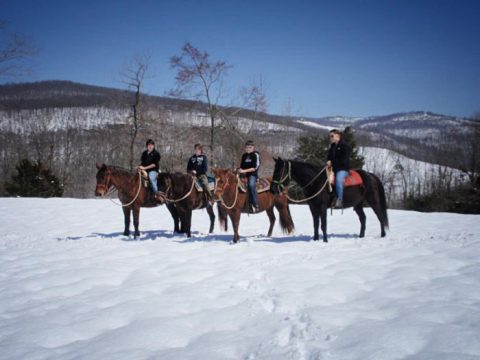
[5,159,63,197]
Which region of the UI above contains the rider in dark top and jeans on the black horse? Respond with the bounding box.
[327,129,350,209]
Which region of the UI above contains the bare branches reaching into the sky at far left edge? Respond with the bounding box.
[0,21,38,79]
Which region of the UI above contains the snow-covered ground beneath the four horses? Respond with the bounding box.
[0,198,480,360]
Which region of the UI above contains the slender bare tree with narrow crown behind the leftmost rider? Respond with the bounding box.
[123,55,150,170]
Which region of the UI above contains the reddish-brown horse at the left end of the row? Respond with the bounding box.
[95,164,174,238]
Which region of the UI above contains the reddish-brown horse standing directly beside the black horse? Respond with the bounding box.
[212,168,294,243]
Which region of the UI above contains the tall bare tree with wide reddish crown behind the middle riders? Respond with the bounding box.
[170,42,231,162]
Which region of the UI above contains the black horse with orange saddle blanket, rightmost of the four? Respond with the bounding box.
[270,158,388,242]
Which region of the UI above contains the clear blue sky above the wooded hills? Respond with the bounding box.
[0,0,480,117]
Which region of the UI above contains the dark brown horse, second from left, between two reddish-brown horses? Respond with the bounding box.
[157,172,215,237]
